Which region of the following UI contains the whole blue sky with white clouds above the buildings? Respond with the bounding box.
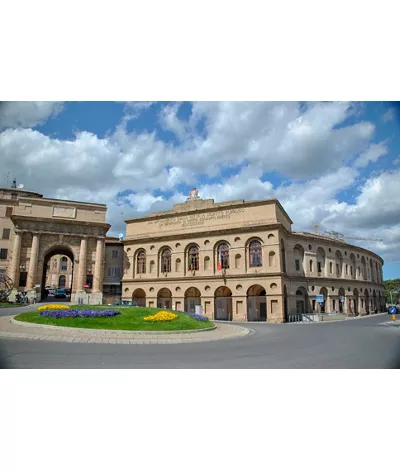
[0,101,400,279]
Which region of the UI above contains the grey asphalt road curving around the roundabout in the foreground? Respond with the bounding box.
[0,315,400,369]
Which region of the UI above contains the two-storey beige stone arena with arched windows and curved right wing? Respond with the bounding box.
[122,191,384,322]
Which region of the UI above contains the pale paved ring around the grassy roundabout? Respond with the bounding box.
[0,312,251,344]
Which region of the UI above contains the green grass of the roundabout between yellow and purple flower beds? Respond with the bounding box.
[15,305,214,331]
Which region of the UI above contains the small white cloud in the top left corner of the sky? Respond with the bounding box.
[0,101,63,130]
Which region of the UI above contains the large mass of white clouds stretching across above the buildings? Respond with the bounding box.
[0,102,400,260]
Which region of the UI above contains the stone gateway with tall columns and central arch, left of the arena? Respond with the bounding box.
[9,198,110,304]
